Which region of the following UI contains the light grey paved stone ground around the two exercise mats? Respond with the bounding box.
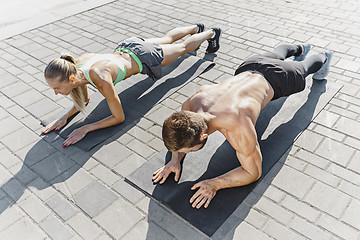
[0,0,360,240]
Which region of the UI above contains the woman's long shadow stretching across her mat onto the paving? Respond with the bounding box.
[0,55,215,214]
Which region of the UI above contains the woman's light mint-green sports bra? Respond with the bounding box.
[77,54,126,88]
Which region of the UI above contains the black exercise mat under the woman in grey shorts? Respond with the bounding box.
[41,54,214,151]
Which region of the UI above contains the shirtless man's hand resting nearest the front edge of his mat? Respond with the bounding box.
[190,180,217,209]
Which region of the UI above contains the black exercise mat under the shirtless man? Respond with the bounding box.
[126,80,341,236]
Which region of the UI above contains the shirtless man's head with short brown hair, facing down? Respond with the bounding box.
[162,111,208,153]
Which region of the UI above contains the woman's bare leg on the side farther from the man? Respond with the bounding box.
[146,25,198,45]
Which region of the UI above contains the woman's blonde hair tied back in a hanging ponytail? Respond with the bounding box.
[44,54,89,112]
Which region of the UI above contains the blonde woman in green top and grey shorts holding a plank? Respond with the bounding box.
[43,23,221,147]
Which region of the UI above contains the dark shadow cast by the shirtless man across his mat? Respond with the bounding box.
[148,80,326,239]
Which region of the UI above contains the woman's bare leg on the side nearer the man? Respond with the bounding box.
[161,30,214,66]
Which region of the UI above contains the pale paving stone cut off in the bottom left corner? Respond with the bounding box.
[0,218,47,240]
